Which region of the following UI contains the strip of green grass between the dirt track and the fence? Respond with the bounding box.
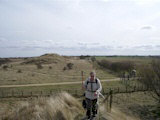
[0,81,125,97]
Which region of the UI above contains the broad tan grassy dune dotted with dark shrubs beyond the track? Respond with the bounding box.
[0,54,115,85]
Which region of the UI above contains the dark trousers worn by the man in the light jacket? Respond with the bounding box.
[86,98,97,117]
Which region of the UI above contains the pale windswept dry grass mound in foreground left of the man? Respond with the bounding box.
[3,92,84,120]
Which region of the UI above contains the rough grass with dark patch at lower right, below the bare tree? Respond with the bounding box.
[113,92,159,120]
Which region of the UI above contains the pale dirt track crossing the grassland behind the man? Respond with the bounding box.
[0,78,120,88]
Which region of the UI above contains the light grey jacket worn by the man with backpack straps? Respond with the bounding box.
[83,77,102,100]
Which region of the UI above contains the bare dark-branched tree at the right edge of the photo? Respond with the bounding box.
[139,60,160,102]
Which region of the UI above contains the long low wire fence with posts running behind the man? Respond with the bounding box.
[0,81,149,98]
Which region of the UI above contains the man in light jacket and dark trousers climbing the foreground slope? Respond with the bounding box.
[84,72,102,119]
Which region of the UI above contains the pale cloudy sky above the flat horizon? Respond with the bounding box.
[0,0,160,57]
